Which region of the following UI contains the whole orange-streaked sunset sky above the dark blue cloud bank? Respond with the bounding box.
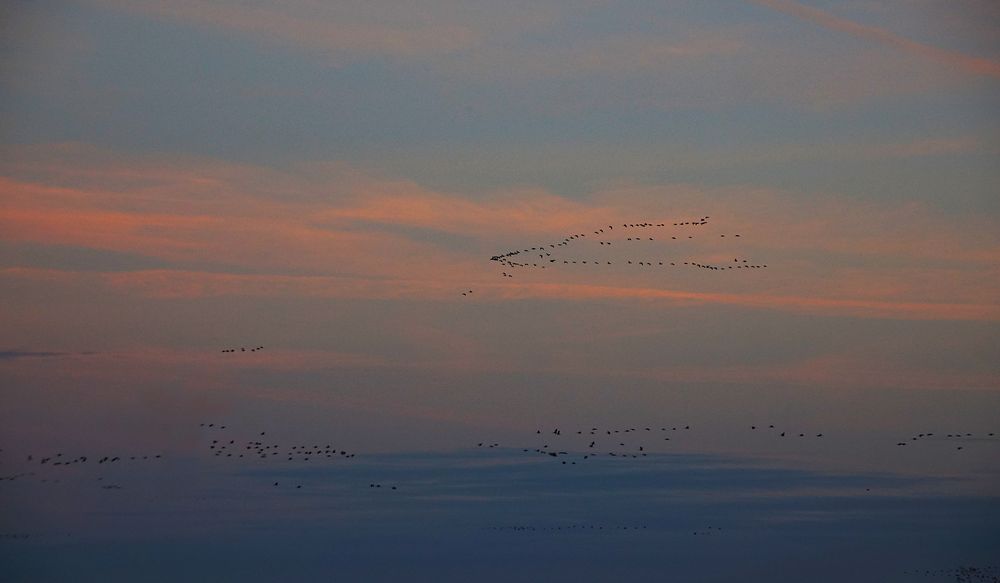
[0,0,1000,580]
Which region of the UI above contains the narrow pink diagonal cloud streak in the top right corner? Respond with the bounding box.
[752,0,1000,77]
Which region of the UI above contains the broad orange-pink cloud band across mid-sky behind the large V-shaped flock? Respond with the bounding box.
[0,144,1000,320]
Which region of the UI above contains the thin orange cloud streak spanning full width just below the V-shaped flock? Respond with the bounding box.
[0,268,1000,321]
